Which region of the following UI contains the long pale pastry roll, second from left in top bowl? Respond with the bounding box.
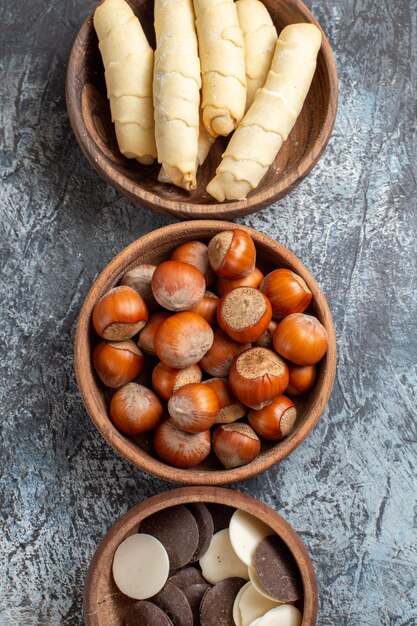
[153,0,201,191]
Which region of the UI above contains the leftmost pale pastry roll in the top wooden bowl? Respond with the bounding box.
[94,0,156,165]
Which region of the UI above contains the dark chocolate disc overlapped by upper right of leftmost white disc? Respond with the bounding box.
[139,505,199,569]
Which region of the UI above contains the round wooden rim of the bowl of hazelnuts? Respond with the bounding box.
[74,220,336,485]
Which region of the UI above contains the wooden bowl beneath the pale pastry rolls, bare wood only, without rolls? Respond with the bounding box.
[66,0,338,219]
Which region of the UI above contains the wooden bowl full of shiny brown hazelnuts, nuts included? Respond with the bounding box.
[75,221,336,485]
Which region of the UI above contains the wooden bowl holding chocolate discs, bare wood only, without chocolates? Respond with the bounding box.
[83,487,318,626]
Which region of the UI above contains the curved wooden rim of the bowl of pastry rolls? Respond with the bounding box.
[65,0,338,220]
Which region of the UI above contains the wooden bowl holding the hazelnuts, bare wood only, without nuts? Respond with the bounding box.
[75,221,336,485]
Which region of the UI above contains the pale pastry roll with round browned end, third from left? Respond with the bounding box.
[194,0,246,137]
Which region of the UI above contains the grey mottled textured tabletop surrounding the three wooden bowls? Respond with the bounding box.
[0,0,417,626]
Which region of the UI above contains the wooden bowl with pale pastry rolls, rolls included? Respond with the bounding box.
[66,0,338,219]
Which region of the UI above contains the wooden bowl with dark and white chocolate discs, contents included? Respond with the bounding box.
[84,487,317,626]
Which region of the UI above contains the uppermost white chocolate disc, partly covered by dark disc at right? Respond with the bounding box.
[229,510,274,566]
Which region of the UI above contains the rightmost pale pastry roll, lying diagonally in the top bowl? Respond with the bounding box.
[207,24,321,202]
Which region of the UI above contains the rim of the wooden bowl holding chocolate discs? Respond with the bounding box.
[83,487,318,626]
